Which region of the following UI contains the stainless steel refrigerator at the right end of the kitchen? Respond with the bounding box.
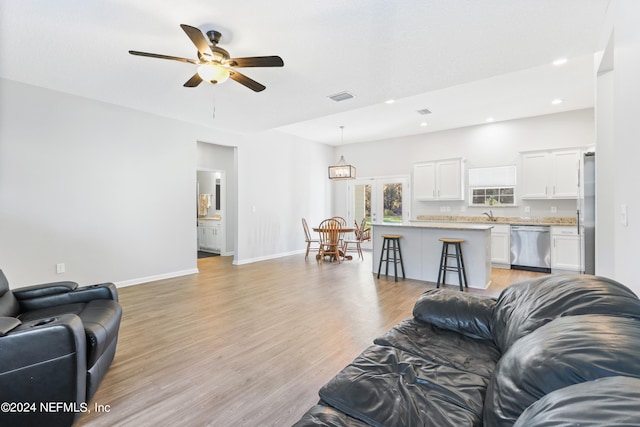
[577,152,596,274]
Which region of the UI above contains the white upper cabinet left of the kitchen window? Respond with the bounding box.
[413,159,464,201]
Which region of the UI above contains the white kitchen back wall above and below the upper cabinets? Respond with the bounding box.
[334,109,595,218]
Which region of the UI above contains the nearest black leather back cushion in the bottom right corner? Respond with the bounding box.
[513,377,640,427]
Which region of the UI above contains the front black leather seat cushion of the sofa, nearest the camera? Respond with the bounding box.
[319,345,488,427]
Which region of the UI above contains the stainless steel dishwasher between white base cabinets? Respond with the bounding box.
[511,225,551,273]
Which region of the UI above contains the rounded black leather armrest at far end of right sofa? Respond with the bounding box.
[413,289,496,340]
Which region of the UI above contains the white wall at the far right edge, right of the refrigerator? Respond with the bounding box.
[596,0,640,295]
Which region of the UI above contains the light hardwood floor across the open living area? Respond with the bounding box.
[76,253,540,427]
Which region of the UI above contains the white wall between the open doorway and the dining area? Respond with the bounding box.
[235,132,331,264]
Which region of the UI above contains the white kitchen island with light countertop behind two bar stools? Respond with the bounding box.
[371,221,493,289]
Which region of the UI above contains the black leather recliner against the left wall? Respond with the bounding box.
[0,270,122,427]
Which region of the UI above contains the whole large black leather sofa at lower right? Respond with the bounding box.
[295,275,640,427]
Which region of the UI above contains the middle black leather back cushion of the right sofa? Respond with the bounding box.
[484,314,640,427]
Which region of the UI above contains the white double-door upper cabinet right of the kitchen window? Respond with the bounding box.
[521,149,582,199]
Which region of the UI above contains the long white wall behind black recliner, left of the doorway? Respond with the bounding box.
[0,81,196,287]
